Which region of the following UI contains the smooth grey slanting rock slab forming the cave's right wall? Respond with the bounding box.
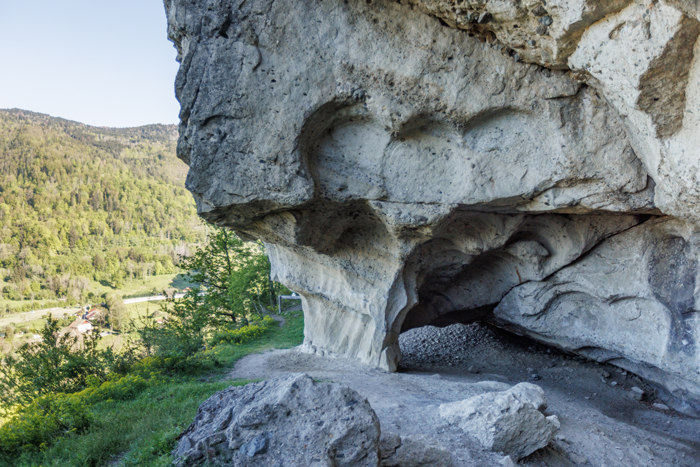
[494,218,700,412]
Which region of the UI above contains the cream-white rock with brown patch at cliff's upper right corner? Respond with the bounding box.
[569,2,700,222]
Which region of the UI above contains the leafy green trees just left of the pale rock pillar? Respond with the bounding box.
[137,228,286,373]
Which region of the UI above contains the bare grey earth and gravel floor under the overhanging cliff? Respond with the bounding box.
[230,323,700,467]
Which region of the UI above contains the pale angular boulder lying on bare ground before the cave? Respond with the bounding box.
[439,383,559,461]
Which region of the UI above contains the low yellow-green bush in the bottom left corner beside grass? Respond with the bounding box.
[0,394,91,457]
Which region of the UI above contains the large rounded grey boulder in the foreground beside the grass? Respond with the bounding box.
[173,373,379,467]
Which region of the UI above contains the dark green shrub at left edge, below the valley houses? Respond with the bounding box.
[0,315,114,411]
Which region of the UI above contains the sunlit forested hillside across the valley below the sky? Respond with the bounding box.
[0,110,204,312]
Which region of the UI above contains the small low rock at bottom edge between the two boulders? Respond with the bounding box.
[379,432,453,467]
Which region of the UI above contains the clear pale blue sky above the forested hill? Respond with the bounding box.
[0,0,180,127]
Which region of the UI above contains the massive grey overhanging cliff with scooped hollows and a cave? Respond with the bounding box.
[165,0,700,411]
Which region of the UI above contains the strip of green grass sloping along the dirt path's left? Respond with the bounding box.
[0,312,304,467]
